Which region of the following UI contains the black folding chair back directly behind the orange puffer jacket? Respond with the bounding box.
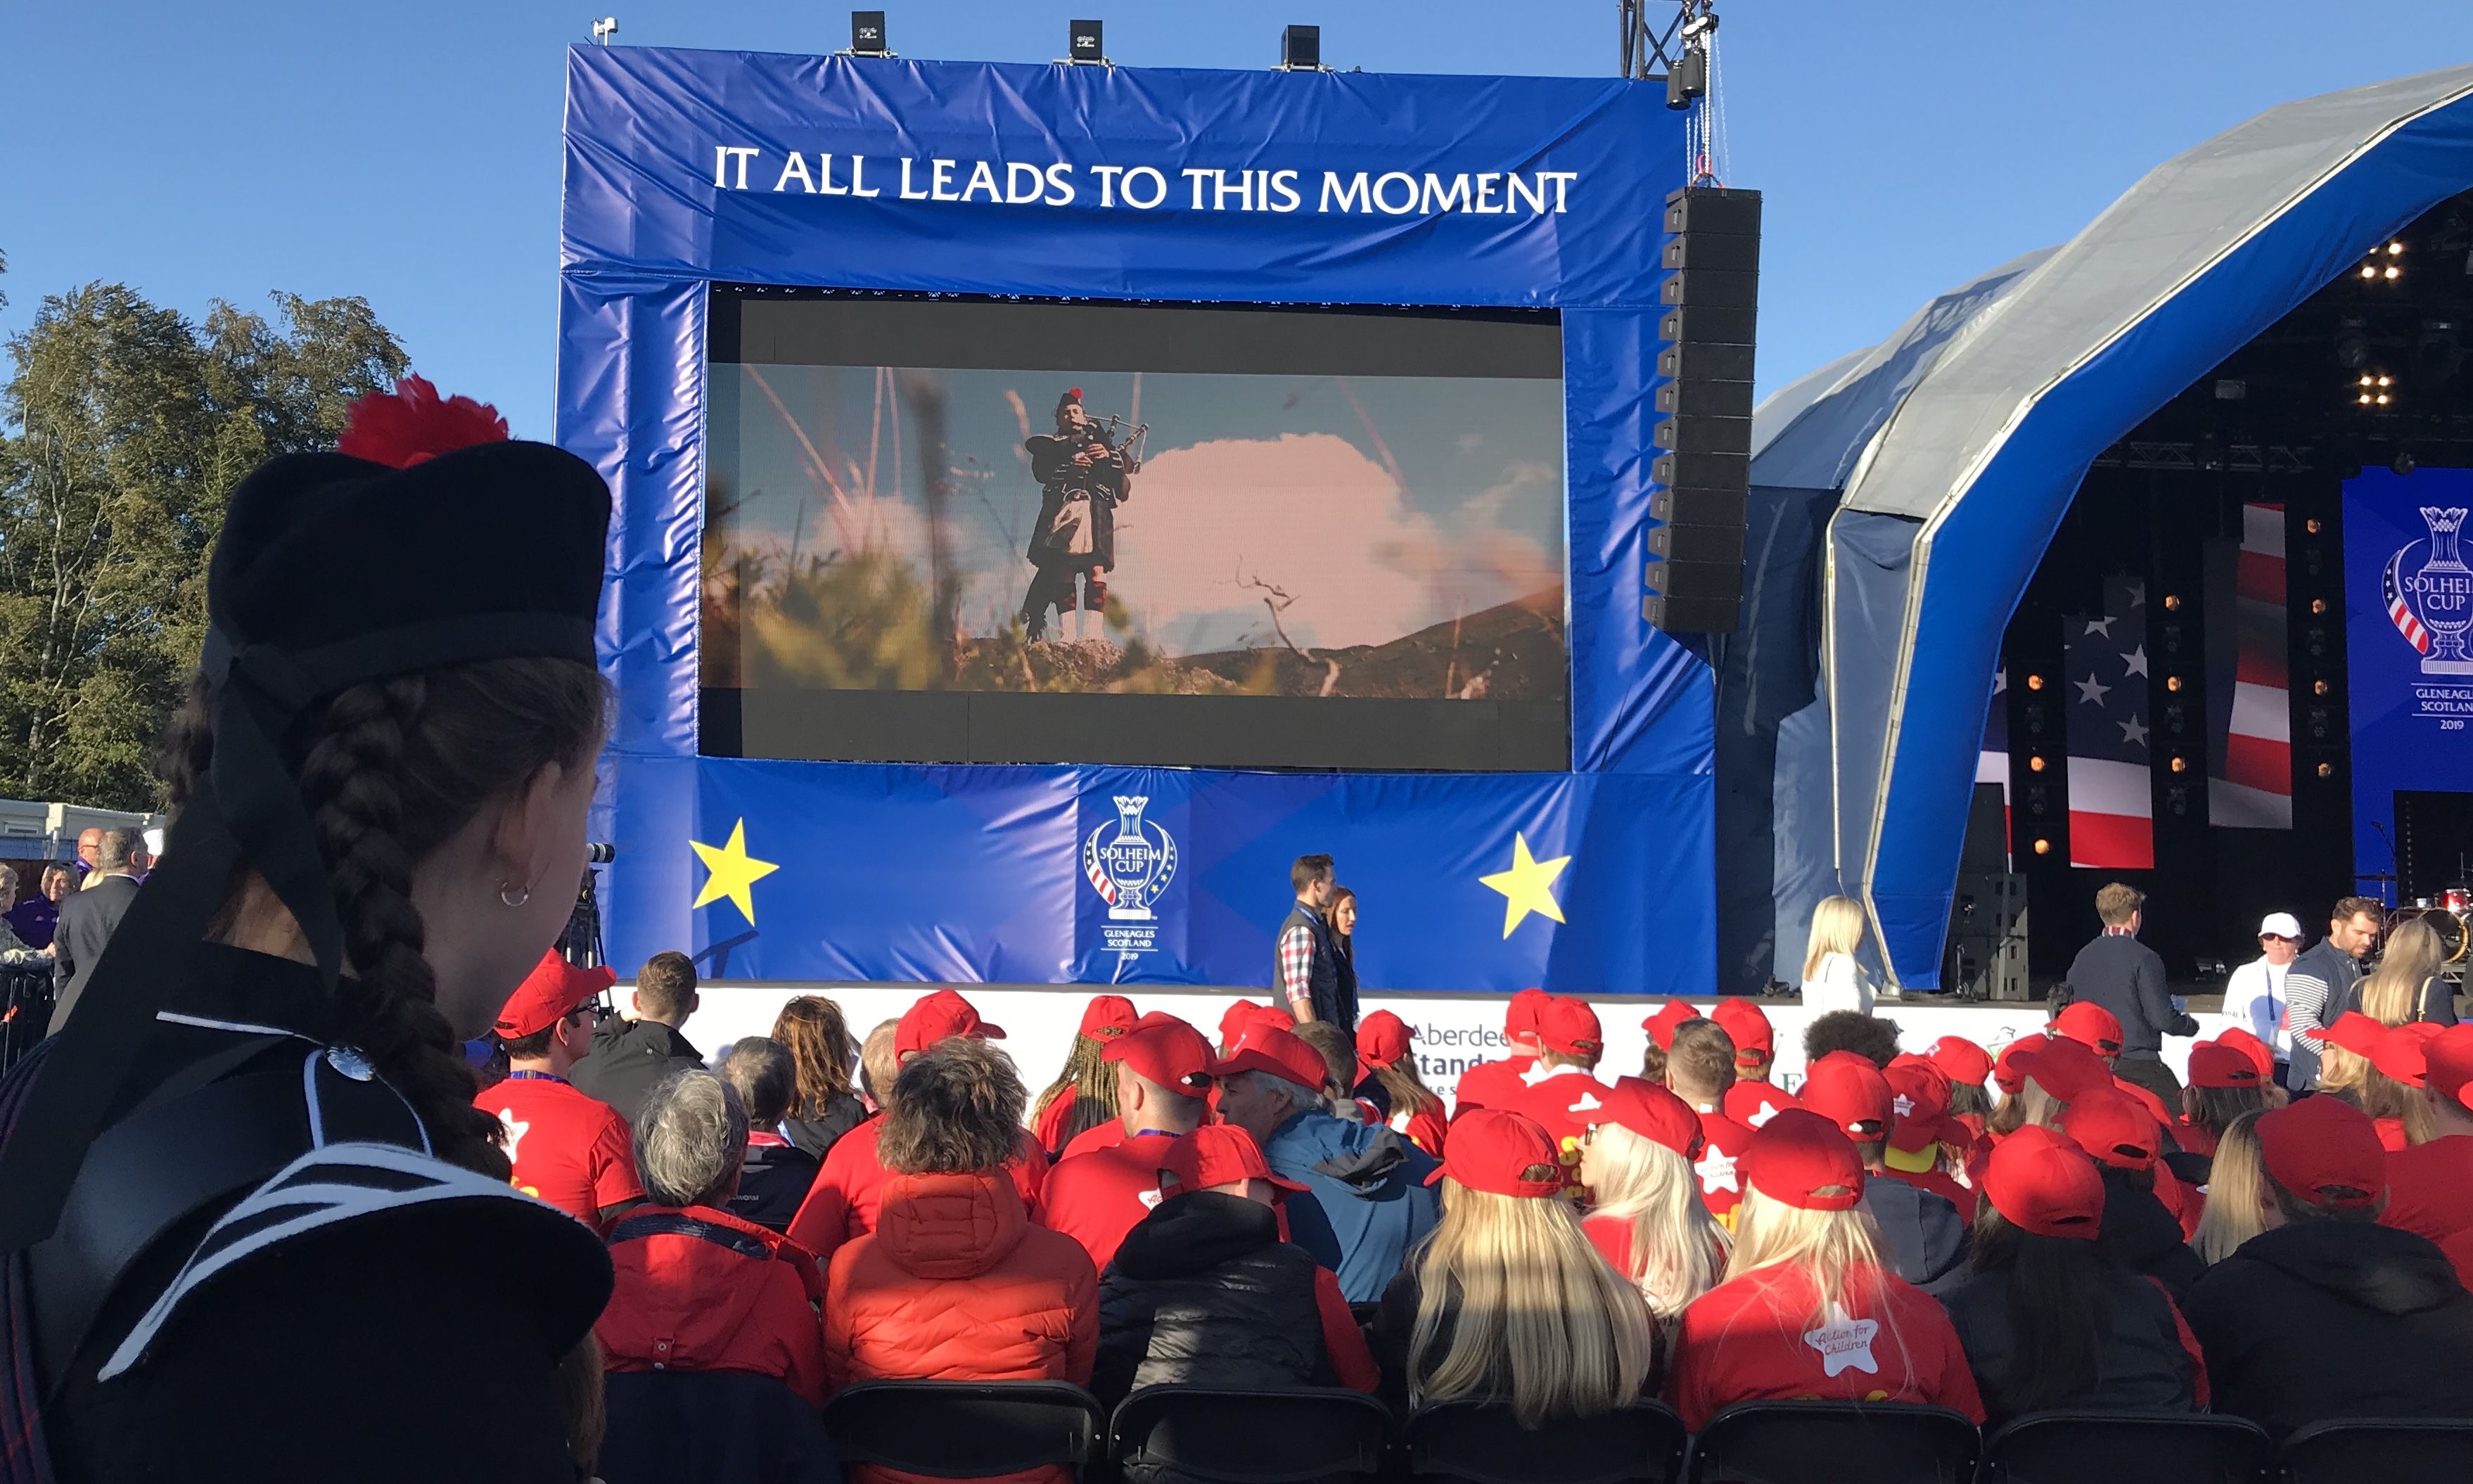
[824,1380,1106,1479]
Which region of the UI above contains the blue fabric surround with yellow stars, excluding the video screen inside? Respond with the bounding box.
[556,47,1714,994]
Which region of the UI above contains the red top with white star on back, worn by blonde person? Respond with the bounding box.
[1672,1264,1983,1432]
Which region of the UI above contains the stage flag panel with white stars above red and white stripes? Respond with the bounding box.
[2060,576,2156,871]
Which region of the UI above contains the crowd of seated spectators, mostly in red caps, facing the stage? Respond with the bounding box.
[519,974,2473,1484]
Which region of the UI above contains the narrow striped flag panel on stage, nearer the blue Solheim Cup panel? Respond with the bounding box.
[2206,504,2292,829]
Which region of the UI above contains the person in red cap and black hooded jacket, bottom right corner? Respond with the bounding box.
[2189,1098,2473,1440]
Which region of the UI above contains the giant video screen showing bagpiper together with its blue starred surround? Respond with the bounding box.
[559,47,1714,994]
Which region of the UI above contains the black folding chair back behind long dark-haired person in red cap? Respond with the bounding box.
[1981,1410,2275,1484]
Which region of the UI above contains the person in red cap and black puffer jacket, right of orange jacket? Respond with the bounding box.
[1091,1123,1375,1414]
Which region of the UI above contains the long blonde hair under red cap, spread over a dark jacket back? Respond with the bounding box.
[1407,1175,1649,1430]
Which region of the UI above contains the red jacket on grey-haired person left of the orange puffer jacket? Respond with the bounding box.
[594,1207,826,1407]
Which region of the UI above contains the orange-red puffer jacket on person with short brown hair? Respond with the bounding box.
[824,1175,1098,1484]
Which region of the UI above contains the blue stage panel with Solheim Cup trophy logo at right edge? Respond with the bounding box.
[2344,470,2473,888]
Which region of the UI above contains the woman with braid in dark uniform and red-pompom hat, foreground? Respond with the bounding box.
[0,378,611,1484]
